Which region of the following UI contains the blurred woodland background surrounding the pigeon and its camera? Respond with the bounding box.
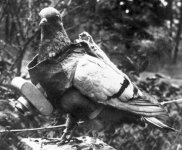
[0,0,182,150]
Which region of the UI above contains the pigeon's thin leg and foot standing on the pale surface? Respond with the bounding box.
[58,114,78,145]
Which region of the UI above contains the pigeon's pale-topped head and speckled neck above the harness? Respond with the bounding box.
[39,7,71,60]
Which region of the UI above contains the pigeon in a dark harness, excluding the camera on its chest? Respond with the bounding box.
[28,7,176,143]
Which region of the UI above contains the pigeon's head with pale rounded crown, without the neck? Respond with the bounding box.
[39,7,62,26]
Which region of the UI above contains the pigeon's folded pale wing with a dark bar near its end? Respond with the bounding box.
[73,54,166,116]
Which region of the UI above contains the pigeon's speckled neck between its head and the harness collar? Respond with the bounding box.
[39,26,71,61]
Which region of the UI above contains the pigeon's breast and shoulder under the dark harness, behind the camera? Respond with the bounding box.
[28,53,84,98]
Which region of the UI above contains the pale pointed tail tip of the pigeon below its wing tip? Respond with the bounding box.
[143,117,178,132]
